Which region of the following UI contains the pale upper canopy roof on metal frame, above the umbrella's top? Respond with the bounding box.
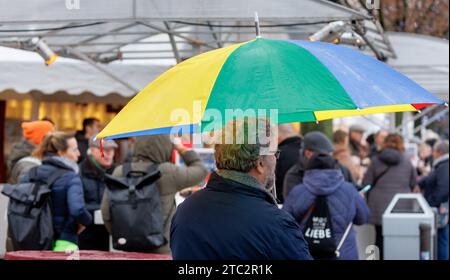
[0,0,372,62]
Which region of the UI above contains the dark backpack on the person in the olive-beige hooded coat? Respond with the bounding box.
[105,162,167,252]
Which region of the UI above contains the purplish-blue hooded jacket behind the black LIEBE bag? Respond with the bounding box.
[283,169,369,260]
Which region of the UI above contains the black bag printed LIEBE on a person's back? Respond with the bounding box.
[303,196,336,260]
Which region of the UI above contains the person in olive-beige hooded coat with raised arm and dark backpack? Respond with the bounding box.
[101,134,208,254]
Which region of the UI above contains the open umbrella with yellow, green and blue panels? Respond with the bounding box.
[97,38,443,139]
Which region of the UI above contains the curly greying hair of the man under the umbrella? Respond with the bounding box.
[214,119,277,173]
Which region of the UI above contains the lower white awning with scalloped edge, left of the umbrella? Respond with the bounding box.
[0,47,168,103]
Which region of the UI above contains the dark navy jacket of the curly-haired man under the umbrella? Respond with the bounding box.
[170,173,311,260]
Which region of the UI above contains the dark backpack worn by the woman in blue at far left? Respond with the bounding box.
[2,167,67,250]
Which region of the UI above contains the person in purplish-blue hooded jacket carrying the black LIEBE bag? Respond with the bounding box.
[283,153,369,260]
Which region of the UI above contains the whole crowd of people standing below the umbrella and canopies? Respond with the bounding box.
[1,118,449,260]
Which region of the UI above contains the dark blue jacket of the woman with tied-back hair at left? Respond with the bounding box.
[21,157,92,243]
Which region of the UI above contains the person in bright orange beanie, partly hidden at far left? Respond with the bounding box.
[6,121,54,183]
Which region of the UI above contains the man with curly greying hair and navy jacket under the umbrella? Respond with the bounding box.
[170,120,311,260]
